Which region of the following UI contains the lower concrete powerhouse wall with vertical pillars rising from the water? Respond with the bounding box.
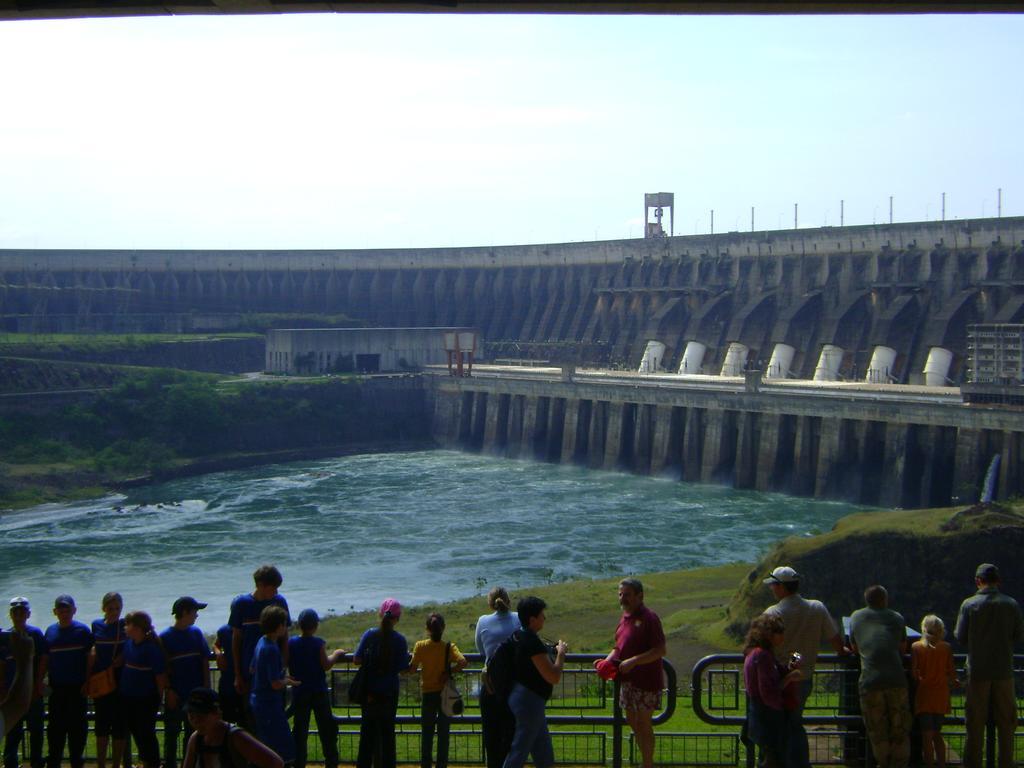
[429,377,1024,508]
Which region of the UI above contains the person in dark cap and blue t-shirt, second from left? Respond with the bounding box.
[45,595,93,768]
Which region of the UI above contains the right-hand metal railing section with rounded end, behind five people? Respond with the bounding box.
[688,653,1024,768]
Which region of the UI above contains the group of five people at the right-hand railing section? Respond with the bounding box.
[743,563,1024,768]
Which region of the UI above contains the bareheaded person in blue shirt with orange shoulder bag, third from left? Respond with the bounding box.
[90,592,128,768]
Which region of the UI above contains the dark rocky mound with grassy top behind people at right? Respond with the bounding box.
[728,505,1024,637]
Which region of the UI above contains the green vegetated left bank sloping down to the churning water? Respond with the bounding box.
[0,370,425,506]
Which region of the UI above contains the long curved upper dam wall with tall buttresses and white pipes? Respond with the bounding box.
[0,217,1024,383]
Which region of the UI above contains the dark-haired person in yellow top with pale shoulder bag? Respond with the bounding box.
[409,613,467,768]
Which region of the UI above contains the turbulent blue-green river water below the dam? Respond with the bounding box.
[0,451,856,631]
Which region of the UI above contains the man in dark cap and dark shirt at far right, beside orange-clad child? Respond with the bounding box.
[953,563,1024,768]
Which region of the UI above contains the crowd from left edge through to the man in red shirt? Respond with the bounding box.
[0,565,665,768]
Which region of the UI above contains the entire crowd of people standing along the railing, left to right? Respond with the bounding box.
[0,563,1024,768]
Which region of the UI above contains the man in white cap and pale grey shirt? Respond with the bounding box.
[764,565,850,768]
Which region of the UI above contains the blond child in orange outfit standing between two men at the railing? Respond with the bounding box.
[910,615,959,768]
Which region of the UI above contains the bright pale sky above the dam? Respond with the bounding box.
[0,14,1024,248]
